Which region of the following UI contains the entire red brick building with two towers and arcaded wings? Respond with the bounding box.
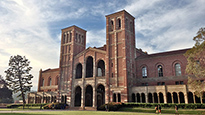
[29,10,204,107]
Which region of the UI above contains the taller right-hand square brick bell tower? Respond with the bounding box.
[106,10,136,102]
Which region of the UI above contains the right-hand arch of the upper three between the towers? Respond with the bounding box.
[97,60,105,76]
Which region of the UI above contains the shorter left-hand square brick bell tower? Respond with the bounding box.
[59,26,86,104]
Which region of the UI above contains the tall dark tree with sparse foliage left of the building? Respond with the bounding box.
[5,55,33,108]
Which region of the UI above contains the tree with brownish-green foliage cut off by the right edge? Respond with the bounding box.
[185,28,205,98]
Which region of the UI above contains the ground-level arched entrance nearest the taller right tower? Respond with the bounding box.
[97,84,105,107]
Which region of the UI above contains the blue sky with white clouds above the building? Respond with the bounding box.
[0,0,205,90]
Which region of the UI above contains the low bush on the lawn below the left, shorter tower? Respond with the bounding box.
[43,103,68,109]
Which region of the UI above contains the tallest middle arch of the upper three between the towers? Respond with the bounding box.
[86,56,93,78]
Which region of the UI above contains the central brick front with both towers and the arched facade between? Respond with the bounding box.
[58,10,136,107]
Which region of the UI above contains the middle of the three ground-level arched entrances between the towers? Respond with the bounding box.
[85,85,93,107]
